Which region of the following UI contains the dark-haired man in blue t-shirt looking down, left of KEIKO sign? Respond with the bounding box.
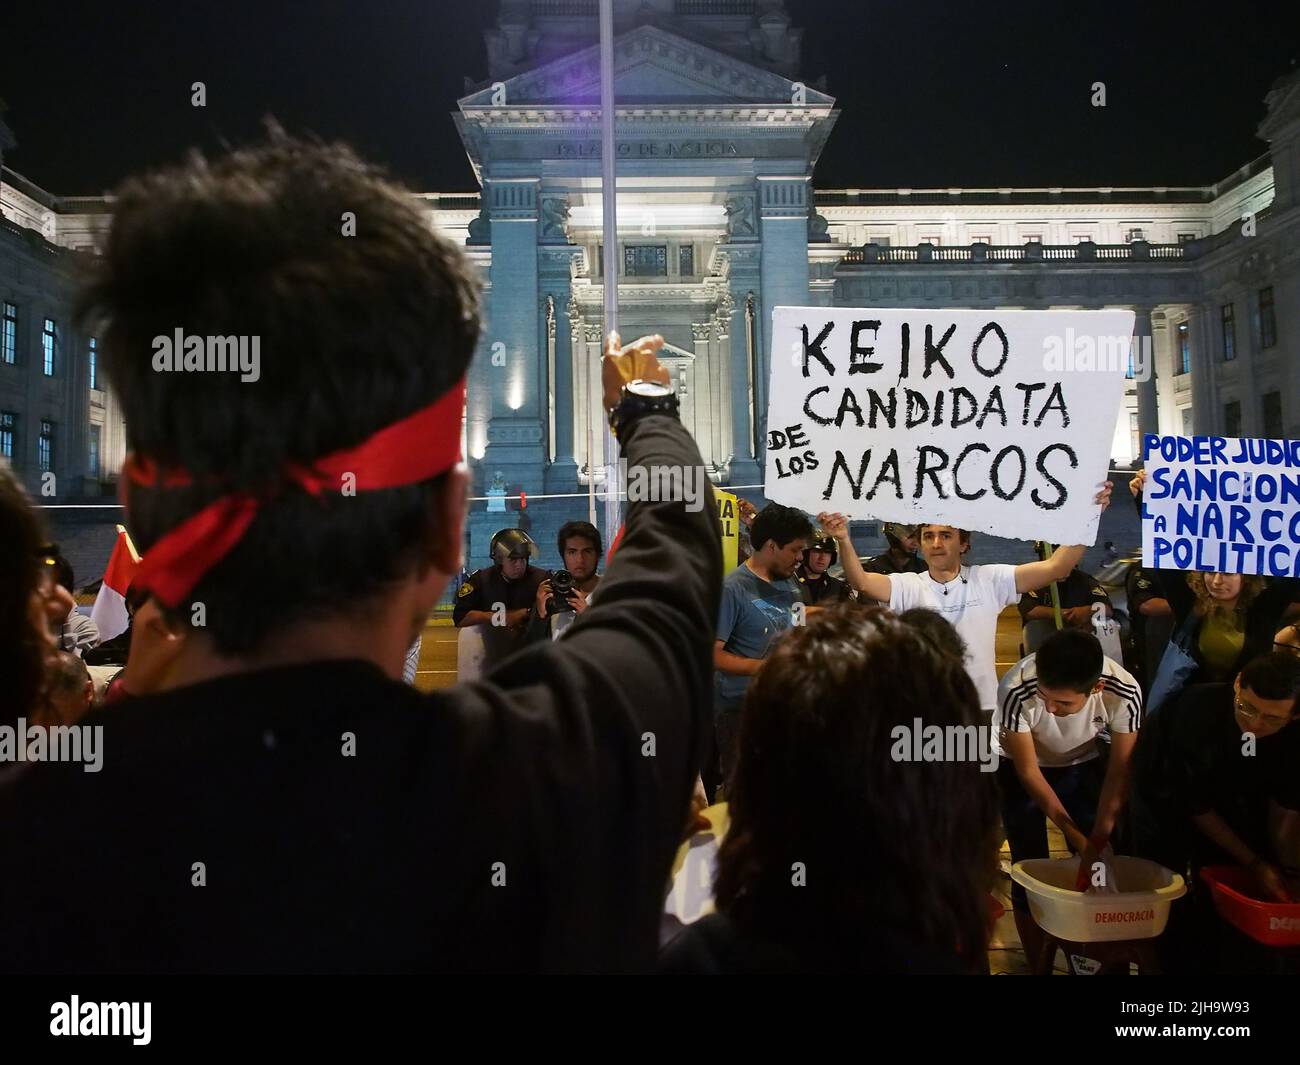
[714,503,813,780]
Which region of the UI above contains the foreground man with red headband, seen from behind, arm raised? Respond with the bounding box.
[0,133,722,974]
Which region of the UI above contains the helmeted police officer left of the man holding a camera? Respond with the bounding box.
[451,529,551,666]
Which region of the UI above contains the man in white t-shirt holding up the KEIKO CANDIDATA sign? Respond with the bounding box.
[818,507,1110,719]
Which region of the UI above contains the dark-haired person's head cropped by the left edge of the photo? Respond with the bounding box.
[0,466,66,733]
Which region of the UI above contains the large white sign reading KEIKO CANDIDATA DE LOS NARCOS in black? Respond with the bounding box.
[764,307,1134,544]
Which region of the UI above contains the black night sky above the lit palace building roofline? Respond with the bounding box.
[0,0,1300,195]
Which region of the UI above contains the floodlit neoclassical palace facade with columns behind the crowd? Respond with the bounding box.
[0,0,1300,555]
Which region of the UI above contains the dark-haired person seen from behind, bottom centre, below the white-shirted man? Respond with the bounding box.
[662,605,998,973]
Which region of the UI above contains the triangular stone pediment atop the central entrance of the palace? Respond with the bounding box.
[459,26,835,113]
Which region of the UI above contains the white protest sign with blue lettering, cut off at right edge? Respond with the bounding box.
[1141,434,1300,577]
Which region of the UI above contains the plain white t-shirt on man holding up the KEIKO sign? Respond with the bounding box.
[889,564,1021,711]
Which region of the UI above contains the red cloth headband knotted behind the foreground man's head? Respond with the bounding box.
[122,378,465,607]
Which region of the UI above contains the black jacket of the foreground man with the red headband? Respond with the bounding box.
[0,416,722,973]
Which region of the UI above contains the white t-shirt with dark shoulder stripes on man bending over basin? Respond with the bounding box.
[993,654,1141,767]
